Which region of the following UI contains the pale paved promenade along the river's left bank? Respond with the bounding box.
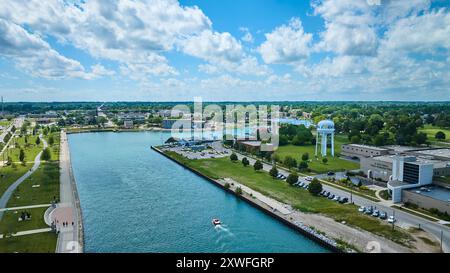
[55,131,83,253]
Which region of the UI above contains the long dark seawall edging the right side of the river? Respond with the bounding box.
[151,146,343,253]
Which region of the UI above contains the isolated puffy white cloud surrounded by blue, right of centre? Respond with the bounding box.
[258,18,312,64]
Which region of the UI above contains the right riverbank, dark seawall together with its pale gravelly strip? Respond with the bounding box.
[151,146,343,252]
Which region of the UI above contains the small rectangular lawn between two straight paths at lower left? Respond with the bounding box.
[0,208,48,234]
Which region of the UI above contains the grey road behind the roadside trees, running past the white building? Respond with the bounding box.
[236,153,450,253]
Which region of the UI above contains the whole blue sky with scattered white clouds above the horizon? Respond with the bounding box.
[0,0,450,101]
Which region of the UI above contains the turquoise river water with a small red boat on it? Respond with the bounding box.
[69,132,327,252]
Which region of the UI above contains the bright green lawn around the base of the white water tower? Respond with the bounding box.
[270,135,359,173]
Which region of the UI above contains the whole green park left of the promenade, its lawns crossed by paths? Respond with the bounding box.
[0,122,60,253]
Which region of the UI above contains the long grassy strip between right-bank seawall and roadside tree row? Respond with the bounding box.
[167,152,412,245]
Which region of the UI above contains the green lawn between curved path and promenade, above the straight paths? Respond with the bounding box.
[8,162,59,207]
